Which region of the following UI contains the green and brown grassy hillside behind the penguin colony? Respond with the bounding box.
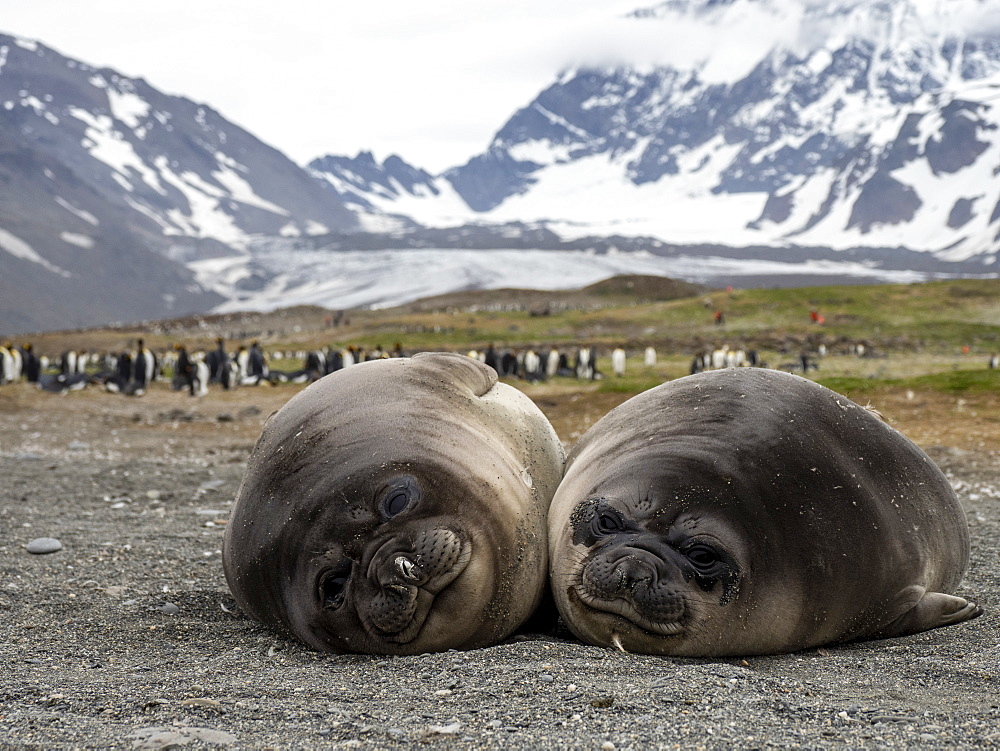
[17,277,1000,370]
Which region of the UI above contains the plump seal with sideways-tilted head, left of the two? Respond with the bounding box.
[223,353,564,654]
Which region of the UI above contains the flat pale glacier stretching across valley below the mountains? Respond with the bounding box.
[188,248,931,313]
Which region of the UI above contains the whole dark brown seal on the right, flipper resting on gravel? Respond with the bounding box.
[549,368,981,656]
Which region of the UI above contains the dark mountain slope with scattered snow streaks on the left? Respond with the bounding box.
[0,34,358,334]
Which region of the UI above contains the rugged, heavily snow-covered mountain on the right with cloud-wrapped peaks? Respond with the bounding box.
[310,0,1000,269]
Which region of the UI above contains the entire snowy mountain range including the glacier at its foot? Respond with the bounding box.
[7,0,1000,333]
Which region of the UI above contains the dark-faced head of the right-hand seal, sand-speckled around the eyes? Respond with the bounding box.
[549,426,757,654]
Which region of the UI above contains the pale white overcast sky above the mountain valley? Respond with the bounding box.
[0,0,655,172]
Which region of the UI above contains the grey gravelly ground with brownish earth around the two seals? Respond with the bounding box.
[0,374,1000,749]
